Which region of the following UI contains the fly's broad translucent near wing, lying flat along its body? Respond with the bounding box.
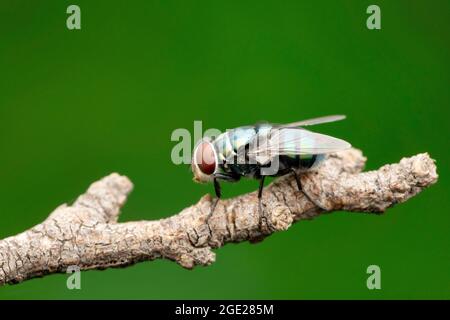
[249,128,351,159]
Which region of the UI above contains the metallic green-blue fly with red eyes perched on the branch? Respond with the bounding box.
[192,115,351,221]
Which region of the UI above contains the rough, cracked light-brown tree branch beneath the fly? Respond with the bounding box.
[0,149,438,285]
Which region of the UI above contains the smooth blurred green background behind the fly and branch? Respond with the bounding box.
[0,0,450,299]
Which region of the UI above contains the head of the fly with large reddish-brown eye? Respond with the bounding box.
[191,139,218,183]
